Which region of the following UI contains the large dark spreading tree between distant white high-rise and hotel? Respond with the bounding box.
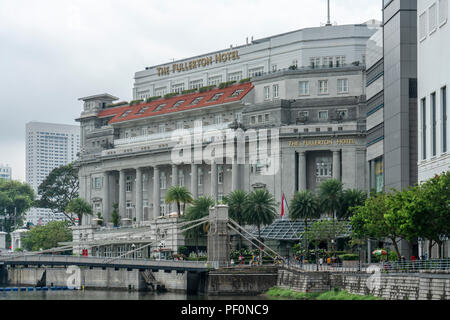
[36,164,79,224]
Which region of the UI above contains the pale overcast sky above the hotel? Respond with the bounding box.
[0,0,381,181]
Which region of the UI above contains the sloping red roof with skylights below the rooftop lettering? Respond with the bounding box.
[98,83,253,124]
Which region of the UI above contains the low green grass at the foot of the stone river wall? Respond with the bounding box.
[266,287,382,300]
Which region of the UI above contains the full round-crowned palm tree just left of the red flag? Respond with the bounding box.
[244,189,276,245]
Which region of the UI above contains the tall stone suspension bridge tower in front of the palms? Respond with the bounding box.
[208,205,230,268]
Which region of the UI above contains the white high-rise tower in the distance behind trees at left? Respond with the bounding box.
[26,122,80,225]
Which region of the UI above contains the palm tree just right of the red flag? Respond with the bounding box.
[290,190,320,255]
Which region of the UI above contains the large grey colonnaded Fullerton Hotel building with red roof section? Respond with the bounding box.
[73,21,379,258]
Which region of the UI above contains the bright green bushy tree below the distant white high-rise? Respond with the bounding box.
[22,221,72,251]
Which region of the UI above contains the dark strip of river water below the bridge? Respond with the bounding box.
[0,290,265,300]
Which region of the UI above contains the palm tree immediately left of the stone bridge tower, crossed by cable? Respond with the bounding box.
[181,197,214,257]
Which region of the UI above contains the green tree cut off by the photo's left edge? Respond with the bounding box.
[0,179,35,233]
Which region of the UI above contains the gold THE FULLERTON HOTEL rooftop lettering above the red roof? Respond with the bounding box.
[157,50,240,77]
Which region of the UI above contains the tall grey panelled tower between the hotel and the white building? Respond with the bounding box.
[383,0,418,191]
